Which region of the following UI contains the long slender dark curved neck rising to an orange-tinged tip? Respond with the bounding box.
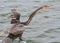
[21,5,49,25]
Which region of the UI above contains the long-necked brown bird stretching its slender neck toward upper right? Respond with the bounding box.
[1,5,49,43]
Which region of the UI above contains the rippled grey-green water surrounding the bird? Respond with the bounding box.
[0,0,60,43]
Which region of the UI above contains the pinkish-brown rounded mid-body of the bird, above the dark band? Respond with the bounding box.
[8,24,25,35]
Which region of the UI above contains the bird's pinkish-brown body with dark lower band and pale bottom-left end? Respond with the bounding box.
[0,24,25,43]
